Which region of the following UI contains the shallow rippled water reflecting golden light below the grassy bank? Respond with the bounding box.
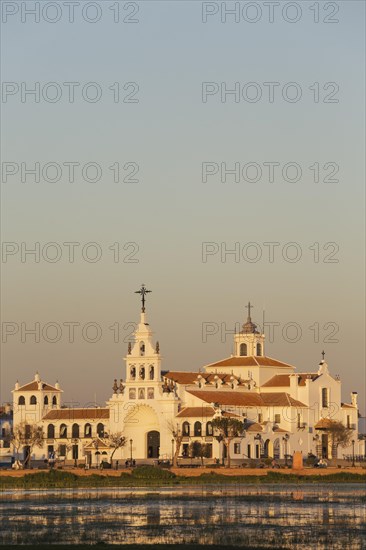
[0,484,366,550]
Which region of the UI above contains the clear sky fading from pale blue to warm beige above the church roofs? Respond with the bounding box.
[1,1,365,413]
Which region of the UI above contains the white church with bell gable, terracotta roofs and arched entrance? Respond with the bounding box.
[13,292,364,466]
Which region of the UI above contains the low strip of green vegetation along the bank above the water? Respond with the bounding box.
[0,466,365,489]
